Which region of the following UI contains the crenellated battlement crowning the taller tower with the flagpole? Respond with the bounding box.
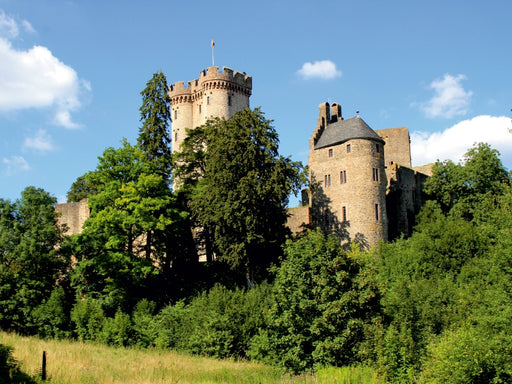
[169,67,252,102]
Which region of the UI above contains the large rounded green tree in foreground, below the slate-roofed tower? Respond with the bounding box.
[250,230,379,372]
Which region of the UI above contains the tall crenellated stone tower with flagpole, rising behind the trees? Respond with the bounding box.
[169,67,252,152]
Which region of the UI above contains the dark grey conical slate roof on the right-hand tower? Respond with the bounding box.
[315,116,384,149]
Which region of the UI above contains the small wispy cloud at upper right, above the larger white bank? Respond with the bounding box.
[413,74,473,118]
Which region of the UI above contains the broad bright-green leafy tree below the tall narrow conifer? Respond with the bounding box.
[73,140,182,311]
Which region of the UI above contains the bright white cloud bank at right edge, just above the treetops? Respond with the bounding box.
[411,115,512,168]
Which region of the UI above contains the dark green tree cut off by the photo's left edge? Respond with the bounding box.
[0,187,69,333]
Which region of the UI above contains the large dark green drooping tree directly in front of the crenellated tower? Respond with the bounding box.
[177,109,302,285]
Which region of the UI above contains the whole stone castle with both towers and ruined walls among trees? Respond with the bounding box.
[56,67,429,247]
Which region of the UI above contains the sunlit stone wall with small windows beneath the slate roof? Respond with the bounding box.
[309,139,388,246]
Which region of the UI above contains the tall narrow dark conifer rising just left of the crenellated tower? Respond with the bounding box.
[137,72,171,179]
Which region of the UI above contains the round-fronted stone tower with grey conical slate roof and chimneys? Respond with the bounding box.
[308,103,388,246]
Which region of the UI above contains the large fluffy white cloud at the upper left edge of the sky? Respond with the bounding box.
[0,11,90,128]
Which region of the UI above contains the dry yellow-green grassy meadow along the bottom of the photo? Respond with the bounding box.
[0,332,381,384]
